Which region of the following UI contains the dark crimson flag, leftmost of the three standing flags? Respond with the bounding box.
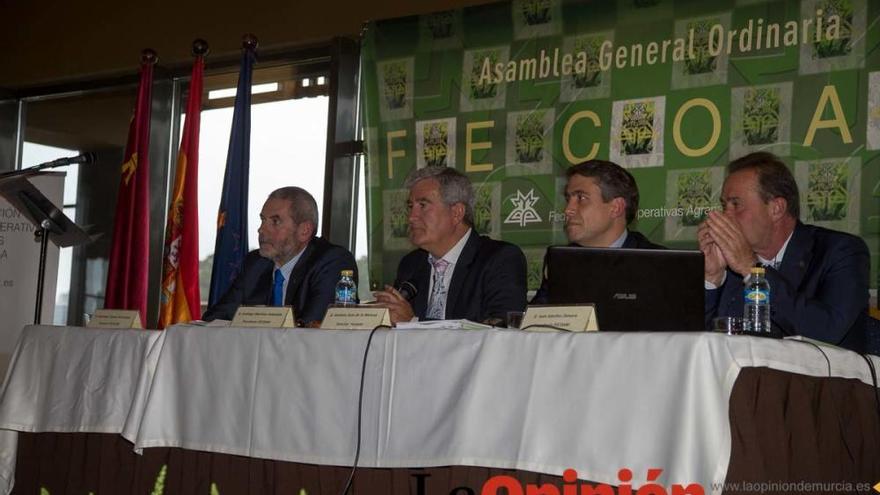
[104,50,156,324]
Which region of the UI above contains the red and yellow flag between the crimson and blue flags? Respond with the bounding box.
[159,47,205,328]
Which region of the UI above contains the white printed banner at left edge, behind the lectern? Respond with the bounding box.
[0,172,65,376]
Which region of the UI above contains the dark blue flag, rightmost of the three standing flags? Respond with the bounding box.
[208,48,256,306]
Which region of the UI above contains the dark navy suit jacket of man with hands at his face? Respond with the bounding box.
[706,222,870,352]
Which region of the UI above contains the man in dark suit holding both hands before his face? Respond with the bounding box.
[698,152,870,352]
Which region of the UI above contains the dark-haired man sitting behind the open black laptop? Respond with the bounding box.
[532,160,665,304]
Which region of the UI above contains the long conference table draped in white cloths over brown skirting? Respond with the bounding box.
[0,325,880,493]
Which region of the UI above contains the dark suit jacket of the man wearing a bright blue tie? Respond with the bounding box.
[202,237,357,324]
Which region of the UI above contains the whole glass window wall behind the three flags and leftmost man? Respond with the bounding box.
[2,40,365,325]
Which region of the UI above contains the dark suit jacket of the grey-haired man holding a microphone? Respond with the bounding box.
[394,230,526,321]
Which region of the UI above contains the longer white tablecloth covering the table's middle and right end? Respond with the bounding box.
[123,326,880,486]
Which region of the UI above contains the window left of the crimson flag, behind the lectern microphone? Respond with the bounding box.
[20,85,140,324]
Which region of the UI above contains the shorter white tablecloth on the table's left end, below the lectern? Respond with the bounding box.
[0,326,162,493]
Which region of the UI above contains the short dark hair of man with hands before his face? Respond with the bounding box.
[727,151,801,219]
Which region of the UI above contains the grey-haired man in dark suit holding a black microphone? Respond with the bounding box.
[375,167,526,323]
